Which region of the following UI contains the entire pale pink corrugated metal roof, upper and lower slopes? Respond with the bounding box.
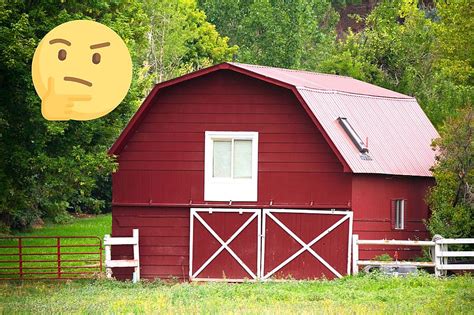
[231,63,439,176]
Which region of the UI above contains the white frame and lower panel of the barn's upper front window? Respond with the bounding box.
[204,131,258,201]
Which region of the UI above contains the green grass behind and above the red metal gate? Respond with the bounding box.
[0,215,112,279]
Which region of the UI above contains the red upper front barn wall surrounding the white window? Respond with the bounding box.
[113,70,351,208]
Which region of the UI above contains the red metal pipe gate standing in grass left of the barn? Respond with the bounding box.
[0,236,102,280]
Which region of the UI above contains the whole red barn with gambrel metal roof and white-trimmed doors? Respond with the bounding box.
[110,63,438,281]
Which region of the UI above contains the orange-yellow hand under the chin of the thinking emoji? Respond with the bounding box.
[41,77,92,120]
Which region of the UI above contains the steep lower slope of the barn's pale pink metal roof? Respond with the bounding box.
[298,88,439,176]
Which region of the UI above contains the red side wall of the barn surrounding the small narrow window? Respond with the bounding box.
[352,174,434,259]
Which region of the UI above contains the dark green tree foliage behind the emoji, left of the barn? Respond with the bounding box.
[0,0,148,230]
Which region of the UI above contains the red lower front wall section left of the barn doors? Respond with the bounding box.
[112,206,189,280]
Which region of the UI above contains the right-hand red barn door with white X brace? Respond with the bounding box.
[261,209,352,280]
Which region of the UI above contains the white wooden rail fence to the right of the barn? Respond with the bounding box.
[352,234,474,276]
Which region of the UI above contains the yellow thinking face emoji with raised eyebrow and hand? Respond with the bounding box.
[32,20,132,120]
